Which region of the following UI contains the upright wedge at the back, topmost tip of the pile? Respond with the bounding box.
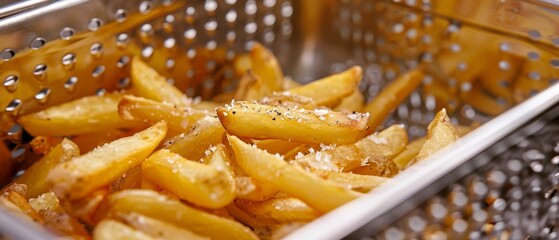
[249,43,283,92]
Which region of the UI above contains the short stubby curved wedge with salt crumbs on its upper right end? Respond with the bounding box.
[142,148,235,209]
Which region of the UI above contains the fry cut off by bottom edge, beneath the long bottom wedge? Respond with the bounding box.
[118,212,209,240]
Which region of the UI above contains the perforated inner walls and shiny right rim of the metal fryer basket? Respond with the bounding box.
[0,0,559,239]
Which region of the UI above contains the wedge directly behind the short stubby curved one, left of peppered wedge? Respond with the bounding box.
[165,117,225,160]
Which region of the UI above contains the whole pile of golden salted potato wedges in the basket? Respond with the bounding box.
[0,44,468,239]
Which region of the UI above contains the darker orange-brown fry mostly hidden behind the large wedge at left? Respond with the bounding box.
[72,129,136,153]
